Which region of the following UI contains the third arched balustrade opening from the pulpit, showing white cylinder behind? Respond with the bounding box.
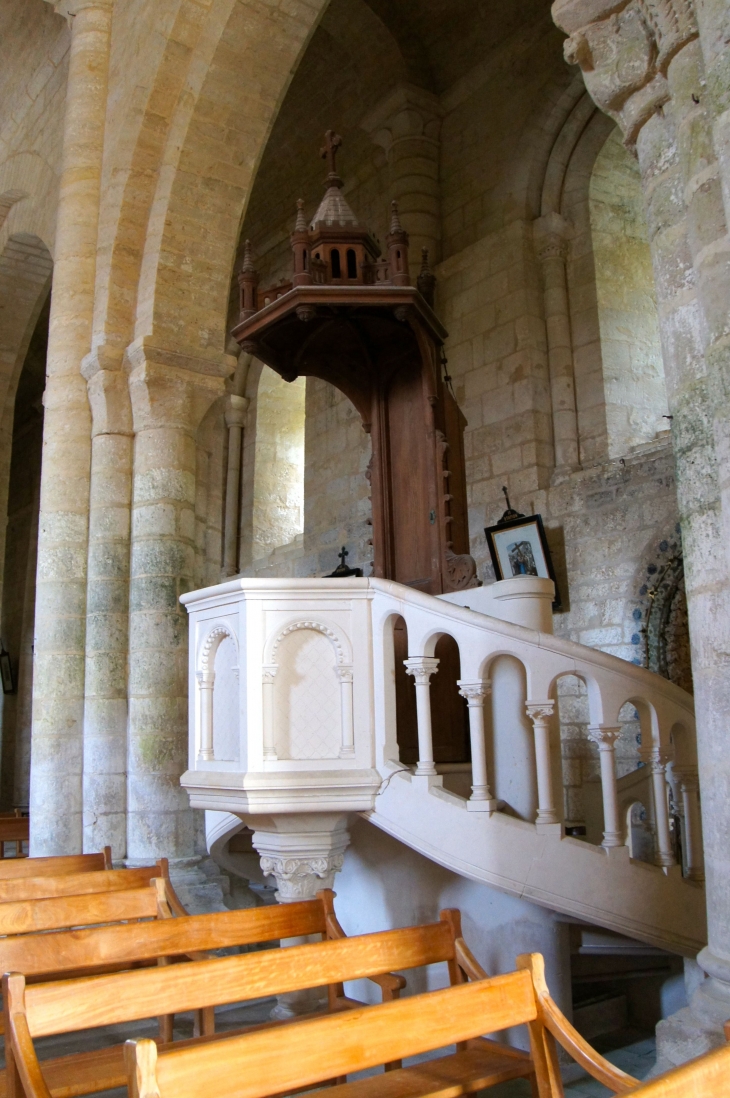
[482,656,538,824]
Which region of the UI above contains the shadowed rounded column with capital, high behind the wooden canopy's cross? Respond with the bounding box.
[360,85,443,261]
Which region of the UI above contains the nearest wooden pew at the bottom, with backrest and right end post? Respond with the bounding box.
[120,954,730,1098]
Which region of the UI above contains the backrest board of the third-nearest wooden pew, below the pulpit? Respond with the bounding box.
[0,900,326,976]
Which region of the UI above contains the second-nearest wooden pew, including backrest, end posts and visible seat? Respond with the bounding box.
[3,909,562,1098]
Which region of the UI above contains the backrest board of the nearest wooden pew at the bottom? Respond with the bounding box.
[132,972,537,1098]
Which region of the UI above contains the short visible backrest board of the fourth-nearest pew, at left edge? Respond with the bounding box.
[0,885,158,934]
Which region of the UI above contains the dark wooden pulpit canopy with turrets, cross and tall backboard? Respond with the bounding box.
[233,131,476,594]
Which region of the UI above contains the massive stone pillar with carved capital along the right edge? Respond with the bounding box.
[552,0,730,1067]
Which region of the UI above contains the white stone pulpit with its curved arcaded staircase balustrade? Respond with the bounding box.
[182,578,706,956]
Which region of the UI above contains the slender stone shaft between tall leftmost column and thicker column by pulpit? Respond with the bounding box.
[83,347,133,861]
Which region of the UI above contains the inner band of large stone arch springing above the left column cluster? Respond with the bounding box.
[135,0,326,362]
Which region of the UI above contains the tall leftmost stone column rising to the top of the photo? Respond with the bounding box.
[30,0,112,855]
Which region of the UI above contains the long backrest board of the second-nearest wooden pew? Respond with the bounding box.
[21,917,454,1036]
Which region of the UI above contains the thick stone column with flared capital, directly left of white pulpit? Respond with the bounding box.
[127,340,231,864]
